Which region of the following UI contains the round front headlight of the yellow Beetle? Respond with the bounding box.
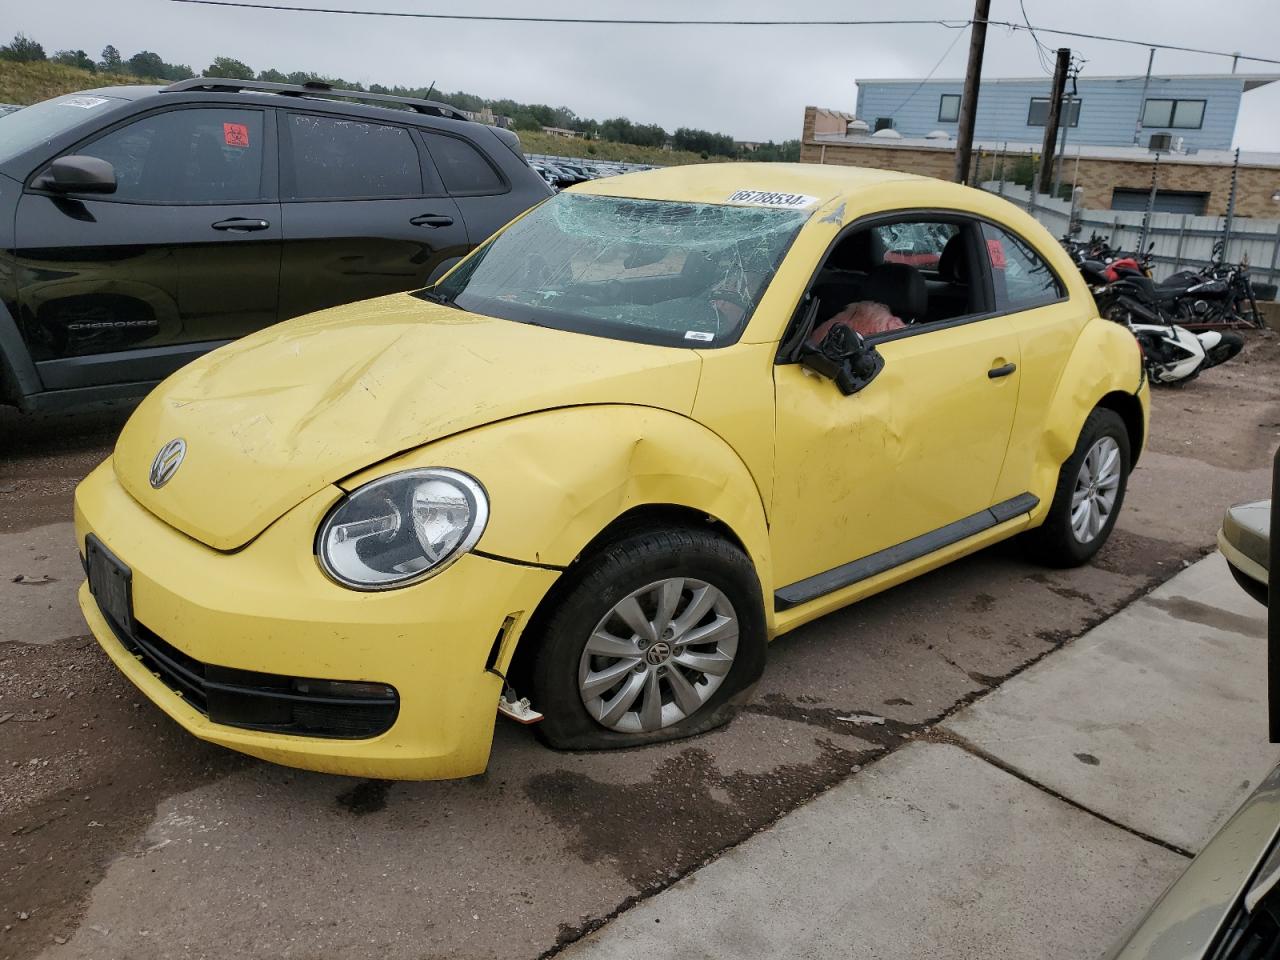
[316,467,489,590]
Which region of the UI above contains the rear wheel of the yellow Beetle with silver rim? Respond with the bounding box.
[1025,407,1132,567]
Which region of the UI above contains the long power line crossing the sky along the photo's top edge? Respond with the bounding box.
[169,0,1280,64]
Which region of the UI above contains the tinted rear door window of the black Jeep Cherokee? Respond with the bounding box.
[284,114,422,200]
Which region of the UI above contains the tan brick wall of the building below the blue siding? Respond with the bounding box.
[800,106,1280,219]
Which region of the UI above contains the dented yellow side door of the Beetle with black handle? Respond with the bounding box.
[771,216,1025,605]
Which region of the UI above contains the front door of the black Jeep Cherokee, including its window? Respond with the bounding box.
[14,105,280,389]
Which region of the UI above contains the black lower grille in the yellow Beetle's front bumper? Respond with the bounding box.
[104,614,399,740]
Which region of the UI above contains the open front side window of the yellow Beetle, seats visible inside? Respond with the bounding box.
[806,215,987,344]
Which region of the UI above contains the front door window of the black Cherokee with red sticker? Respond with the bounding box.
[74,108,262,204]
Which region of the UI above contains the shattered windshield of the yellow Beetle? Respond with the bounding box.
[429,193,810,347]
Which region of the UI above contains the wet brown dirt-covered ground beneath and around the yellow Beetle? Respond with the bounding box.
[0,333,1280,957]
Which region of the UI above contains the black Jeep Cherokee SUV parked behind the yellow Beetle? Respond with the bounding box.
[0,78,552,410]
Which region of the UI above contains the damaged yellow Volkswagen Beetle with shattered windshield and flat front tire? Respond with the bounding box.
[76,164,1148,778]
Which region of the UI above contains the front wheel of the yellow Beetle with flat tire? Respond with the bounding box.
[532,527,767,750]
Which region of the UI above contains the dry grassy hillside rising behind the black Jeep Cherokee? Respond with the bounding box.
[0,60,727,166]
